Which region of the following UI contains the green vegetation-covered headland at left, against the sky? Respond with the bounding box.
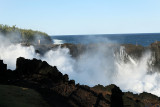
[0,24,52,43]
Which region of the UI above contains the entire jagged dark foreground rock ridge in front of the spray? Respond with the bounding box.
[0,57,160,107]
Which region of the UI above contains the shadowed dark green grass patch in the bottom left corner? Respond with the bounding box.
[0,85,49,107]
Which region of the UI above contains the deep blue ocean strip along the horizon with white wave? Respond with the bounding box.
[52,33,160,46]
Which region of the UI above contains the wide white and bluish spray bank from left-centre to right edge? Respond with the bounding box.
[43,45,160,96]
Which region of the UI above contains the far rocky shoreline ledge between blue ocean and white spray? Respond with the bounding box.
[32,41,160,69]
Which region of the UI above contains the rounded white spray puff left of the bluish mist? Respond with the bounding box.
[41,47,76,74]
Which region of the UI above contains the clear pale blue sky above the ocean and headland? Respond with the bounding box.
[0,0,160,35]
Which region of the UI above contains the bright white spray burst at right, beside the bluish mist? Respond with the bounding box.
[114,47,160,94]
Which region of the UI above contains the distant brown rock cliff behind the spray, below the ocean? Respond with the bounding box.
[34,41,160,59]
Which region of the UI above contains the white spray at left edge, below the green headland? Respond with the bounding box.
[0,44,39,70]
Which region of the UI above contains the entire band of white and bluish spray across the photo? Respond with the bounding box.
[0,36,160,96]
